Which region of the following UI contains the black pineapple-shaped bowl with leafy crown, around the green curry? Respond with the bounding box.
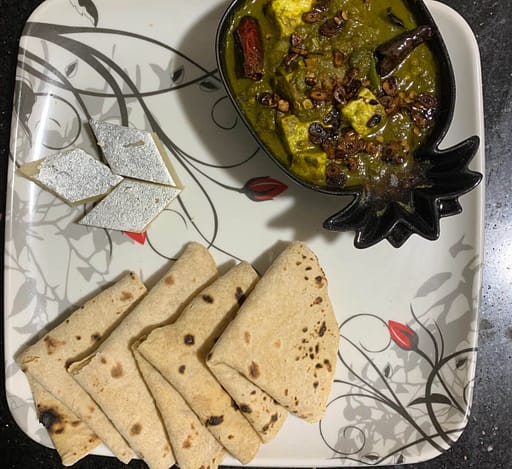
[216,0,482,248]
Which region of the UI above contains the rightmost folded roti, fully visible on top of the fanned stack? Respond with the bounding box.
[207,241,339,422]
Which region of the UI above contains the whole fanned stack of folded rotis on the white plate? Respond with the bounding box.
[18,241,339,469]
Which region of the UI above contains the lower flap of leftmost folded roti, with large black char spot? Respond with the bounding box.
[27,375,101,466]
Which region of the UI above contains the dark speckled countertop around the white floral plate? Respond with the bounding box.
[0,0,512,469]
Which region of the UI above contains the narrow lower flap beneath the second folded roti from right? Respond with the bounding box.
[134,350,226,469]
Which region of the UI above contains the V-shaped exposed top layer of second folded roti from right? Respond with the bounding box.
[137,262,260,463]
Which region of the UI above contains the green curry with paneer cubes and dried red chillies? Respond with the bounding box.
[226,0,437,198]
